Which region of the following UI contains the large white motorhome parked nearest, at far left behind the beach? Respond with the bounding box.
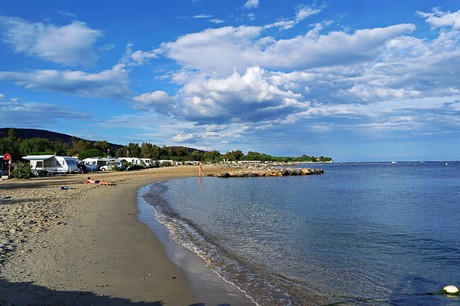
[22,155,78,176]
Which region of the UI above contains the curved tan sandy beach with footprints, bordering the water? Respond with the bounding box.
[0,166,252,305]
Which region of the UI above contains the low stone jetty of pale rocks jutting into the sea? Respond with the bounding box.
[210,168,324,178]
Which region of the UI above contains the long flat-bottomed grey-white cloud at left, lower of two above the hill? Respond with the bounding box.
[0,65,130,99]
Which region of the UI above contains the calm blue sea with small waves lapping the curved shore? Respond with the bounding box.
[140,161,460,305]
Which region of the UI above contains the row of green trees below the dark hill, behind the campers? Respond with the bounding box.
[0,129,332,163]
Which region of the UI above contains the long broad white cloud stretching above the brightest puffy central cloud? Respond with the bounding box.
[162,24,415,73]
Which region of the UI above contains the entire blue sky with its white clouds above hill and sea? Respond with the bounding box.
[0,0,460,161]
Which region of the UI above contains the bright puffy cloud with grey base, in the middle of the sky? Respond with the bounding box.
[179,67,308,123]
